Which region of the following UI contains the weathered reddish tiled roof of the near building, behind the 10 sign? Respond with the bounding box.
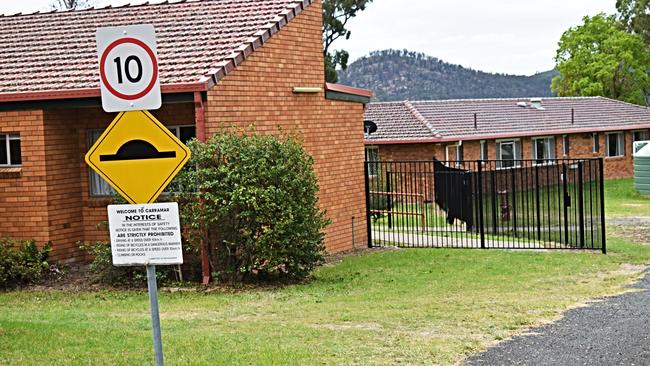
[0,0,312,101]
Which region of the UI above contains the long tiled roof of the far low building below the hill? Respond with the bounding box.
[365,97,650,143]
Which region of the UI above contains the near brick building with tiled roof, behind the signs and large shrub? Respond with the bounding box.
[0,0,371,261]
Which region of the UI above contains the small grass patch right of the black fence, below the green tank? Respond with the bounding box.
[605,178,650,217]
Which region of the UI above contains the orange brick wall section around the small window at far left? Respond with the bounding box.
[0,110,50,245]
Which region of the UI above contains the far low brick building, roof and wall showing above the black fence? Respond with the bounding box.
[365,97,650,178]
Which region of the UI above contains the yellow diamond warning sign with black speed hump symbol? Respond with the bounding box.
[86,111,190,204]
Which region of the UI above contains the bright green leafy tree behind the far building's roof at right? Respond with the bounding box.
[551,14,650,105]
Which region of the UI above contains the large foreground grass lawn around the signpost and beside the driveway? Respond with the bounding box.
[0,181,650,365]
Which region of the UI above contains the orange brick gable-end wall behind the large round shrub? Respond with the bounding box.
[205,1,367,252]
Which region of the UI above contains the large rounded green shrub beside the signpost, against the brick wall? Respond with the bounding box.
[174,133,328,281]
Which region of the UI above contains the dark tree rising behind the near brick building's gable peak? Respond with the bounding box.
[323,0,372,83]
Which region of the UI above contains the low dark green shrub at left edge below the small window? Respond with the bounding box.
[0,239,52,289]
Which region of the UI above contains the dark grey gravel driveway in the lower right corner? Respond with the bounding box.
[465,271,650,366]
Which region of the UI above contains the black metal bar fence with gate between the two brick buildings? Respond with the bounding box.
[365,158,606,253]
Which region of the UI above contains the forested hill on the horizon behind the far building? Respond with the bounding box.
[339,50,557,101]
